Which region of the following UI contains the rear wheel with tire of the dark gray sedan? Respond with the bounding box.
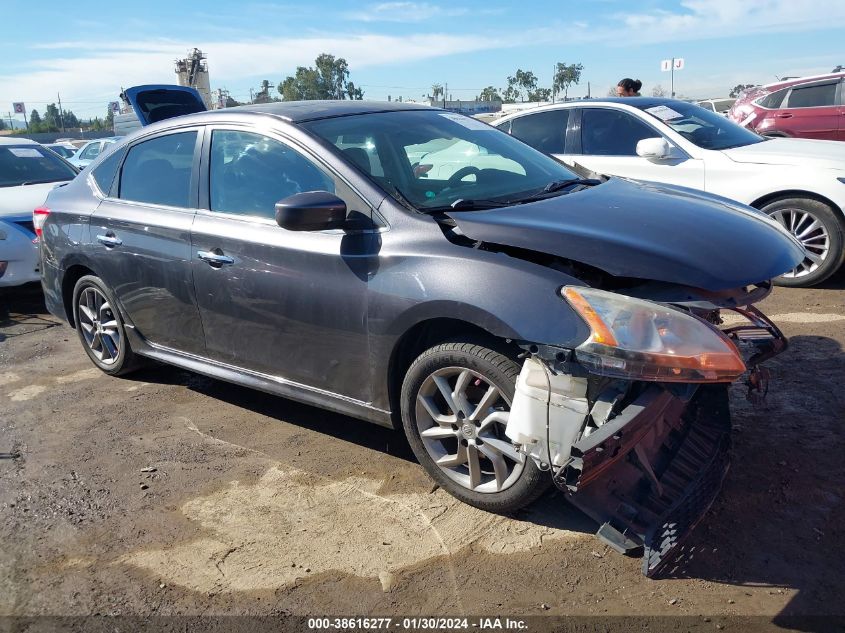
[73,275,138,376]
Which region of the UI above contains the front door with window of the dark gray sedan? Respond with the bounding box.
[192,127,379,401]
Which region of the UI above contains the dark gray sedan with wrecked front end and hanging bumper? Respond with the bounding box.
[37,86,803,573]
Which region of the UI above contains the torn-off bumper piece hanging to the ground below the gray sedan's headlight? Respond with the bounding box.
[556,385,731,576]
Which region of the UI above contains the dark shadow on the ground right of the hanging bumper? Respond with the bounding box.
[662,336,845,631]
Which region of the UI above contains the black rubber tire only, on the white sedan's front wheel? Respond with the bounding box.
[761,197,845,288]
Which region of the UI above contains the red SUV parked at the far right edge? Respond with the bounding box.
[728,73,845,141]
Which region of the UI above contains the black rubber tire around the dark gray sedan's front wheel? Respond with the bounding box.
[401,341,551,514]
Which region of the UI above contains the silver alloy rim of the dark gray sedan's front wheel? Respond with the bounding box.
[416,367,525,493]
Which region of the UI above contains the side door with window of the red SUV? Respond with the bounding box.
[767,80,842,140]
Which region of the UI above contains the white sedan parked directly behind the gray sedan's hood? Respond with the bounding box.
[494,97,845,286]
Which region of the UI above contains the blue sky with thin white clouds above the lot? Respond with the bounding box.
[0,0,845,119]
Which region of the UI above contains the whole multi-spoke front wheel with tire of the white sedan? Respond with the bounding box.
[761,198,845,288]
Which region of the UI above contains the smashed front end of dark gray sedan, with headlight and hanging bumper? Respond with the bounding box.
[506,285,786,577]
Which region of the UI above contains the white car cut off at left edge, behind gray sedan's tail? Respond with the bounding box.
[0,138,76,287]
